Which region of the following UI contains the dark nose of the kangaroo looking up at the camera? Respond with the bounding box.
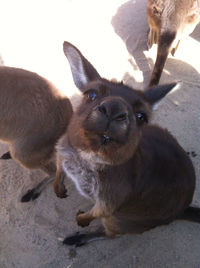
[98,102,128,121]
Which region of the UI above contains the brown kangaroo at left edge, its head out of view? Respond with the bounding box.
[0,66,72,202]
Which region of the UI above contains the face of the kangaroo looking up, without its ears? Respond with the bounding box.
[68,80,150,164]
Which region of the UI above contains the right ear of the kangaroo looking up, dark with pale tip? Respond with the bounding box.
[144,82,181,109]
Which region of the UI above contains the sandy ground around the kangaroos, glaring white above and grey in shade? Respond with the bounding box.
[0,0,200,268]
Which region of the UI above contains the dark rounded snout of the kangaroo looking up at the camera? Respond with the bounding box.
[82,97,135,157]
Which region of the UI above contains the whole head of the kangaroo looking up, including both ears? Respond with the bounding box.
[63,42,176,165]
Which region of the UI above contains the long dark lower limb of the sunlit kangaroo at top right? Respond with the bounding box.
[148,32,176,87]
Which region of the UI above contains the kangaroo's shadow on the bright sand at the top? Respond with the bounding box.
[111,0,153,85]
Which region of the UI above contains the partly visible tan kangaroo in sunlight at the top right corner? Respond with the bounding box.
[147,0,200,87]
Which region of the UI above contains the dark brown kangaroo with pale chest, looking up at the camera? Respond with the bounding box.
[54,42,200,246]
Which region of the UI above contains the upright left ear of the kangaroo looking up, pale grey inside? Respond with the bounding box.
[63,41,101,91]
